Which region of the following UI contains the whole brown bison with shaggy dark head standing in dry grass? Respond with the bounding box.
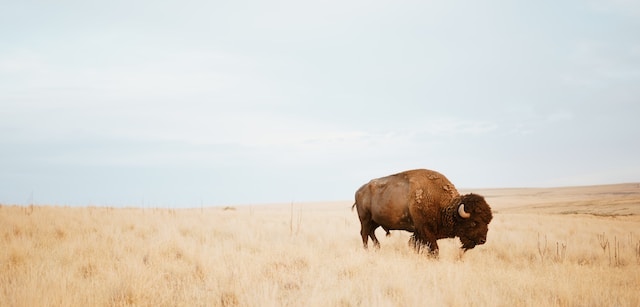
[351,169,492,256]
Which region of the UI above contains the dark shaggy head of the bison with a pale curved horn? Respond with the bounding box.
[456,193,493,251]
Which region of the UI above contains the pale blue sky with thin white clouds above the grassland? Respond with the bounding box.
[0,1,640,207]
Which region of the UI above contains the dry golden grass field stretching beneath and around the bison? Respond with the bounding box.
[0,184,640,306]
